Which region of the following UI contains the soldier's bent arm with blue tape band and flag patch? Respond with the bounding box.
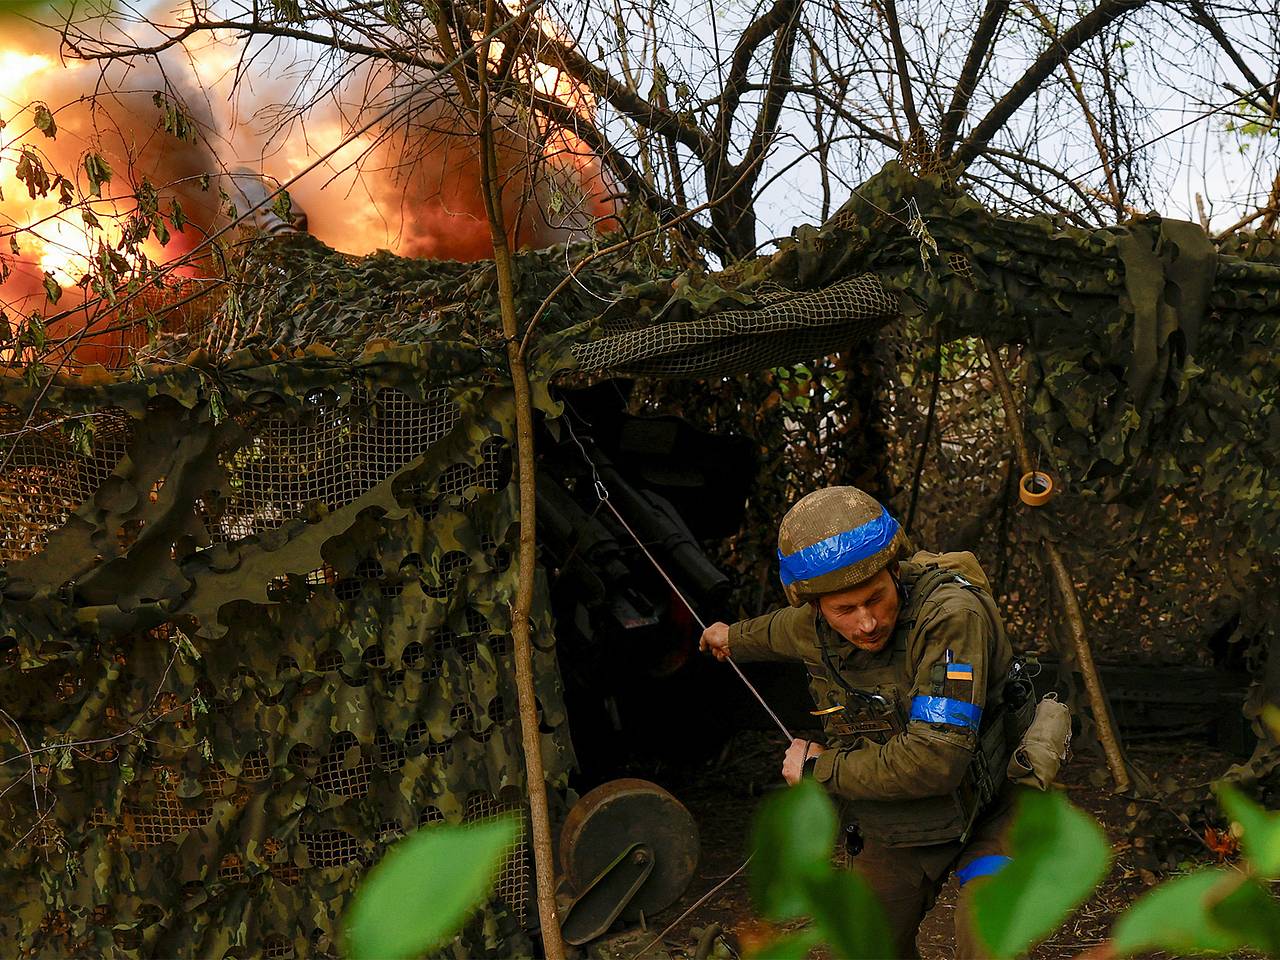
[814,586,993,800]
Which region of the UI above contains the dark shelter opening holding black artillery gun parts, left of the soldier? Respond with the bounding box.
[536,384,755,792]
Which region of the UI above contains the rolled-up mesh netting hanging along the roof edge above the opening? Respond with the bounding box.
[573,274,899,376]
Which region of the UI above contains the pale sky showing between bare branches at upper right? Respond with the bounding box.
[573,0,1280,241]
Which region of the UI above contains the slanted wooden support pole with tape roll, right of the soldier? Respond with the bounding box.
[982,337,1132,792]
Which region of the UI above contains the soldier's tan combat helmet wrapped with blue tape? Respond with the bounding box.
[778,486,906,607]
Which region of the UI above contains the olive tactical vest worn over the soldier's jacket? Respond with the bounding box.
[805,554,1034,846]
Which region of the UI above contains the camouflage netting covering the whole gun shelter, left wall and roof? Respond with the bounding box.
[0,166,1280,956]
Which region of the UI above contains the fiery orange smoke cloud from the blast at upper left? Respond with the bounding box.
[0,14,613,365]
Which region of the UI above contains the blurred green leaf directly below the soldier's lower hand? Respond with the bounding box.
[750,780,836,920]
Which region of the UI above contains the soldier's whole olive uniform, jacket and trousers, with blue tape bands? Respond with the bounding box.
[728,553,1014,956]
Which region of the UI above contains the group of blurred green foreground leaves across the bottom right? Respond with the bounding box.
[751,781,1280,960]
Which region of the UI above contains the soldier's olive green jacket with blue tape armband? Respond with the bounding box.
[728,553,1012,800]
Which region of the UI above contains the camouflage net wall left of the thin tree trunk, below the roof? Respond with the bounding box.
[0,344,572,957]
